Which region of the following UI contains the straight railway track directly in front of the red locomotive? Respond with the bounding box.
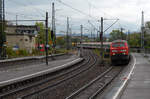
[65,67,123,99]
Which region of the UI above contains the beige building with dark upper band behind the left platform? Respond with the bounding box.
[5,25,37,53]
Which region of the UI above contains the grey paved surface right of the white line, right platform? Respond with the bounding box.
[120,53,150,99]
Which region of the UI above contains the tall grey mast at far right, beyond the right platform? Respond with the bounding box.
[141,11,144,48]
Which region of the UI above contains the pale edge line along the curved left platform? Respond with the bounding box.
[0,58,81,85]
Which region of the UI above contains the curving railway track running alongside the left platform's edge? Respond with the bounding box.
[0,52,96,99]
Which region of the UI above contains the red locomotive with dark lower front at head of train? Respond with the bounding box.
[110,40,130,64]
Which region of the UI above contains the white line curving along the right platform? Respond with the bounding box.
[112,55,136,99]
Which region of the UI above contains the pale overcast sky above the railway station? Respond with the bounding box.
[5,0,150,33]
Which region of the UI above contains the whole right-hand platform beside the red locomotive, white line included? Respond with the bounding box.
[99,53,150,99]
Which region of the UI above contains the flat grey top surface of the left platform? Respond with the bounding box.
[0,55,81,85]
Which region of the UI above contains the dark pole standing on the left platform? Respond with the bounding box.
[45,12,49,65]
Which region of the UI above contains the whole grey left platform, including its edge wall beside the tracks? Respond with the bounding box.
[0,55,83,87]
